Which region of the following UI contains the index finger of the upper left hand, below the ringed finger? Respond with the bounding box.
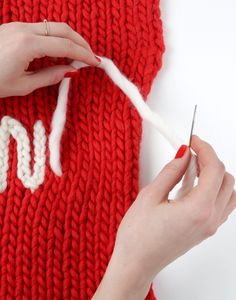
[29,36,99,66]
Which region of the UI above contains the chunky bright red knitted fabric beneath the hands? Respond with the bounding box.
[0,0,164,300]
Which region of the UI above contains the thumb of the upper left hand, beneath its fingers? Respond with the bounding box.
[21,65,76,93]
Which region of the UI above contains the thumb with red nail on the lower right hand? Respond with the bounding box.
[150,145,191,202]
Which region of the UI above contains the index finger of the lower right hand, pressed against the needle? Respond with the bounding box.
[188,136,225,201]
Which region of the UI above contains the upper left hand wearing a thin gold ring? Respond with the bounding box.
[0,22,99,98]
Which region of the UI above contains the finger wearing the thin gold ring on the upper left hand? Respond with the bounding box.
[21,22,93,53]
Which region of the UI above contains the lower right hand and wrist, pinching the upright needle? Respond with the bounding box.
[93,136,236,300]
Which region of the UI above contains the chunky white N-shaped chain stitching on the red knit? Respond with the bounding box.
[0,116,46,192]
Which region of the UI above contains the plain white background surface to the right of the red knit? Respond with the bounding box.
[140,0,236,300]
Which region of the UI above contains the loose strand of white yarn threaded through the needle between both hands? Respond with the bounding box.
[49,57,197,197]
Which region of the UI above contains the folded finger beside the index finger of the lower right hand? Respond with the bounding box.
[215,172,235,218]
